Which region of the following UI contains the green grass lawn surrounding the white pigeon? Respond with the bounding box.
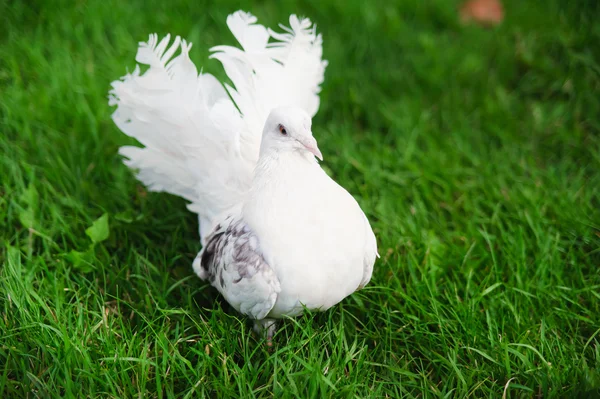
[0,0,600,398]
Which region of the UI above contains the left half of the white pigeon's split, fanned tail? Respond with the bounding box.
[109,35,251,238]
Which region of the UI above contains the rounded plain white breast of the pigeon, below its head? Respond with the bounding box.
[244,155,365,317]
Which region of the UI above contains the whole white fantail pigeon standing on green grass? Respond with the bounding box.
[108,11,379,345]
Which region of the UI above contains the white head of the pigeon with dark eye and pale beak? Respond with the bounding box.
[261,107,323,160]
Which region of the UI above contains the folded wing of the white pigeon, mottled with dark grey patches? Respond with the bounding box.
[194,217,281,320]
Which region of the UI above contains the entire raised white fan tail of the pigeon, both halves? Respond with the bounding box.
[109,11,327,244]
